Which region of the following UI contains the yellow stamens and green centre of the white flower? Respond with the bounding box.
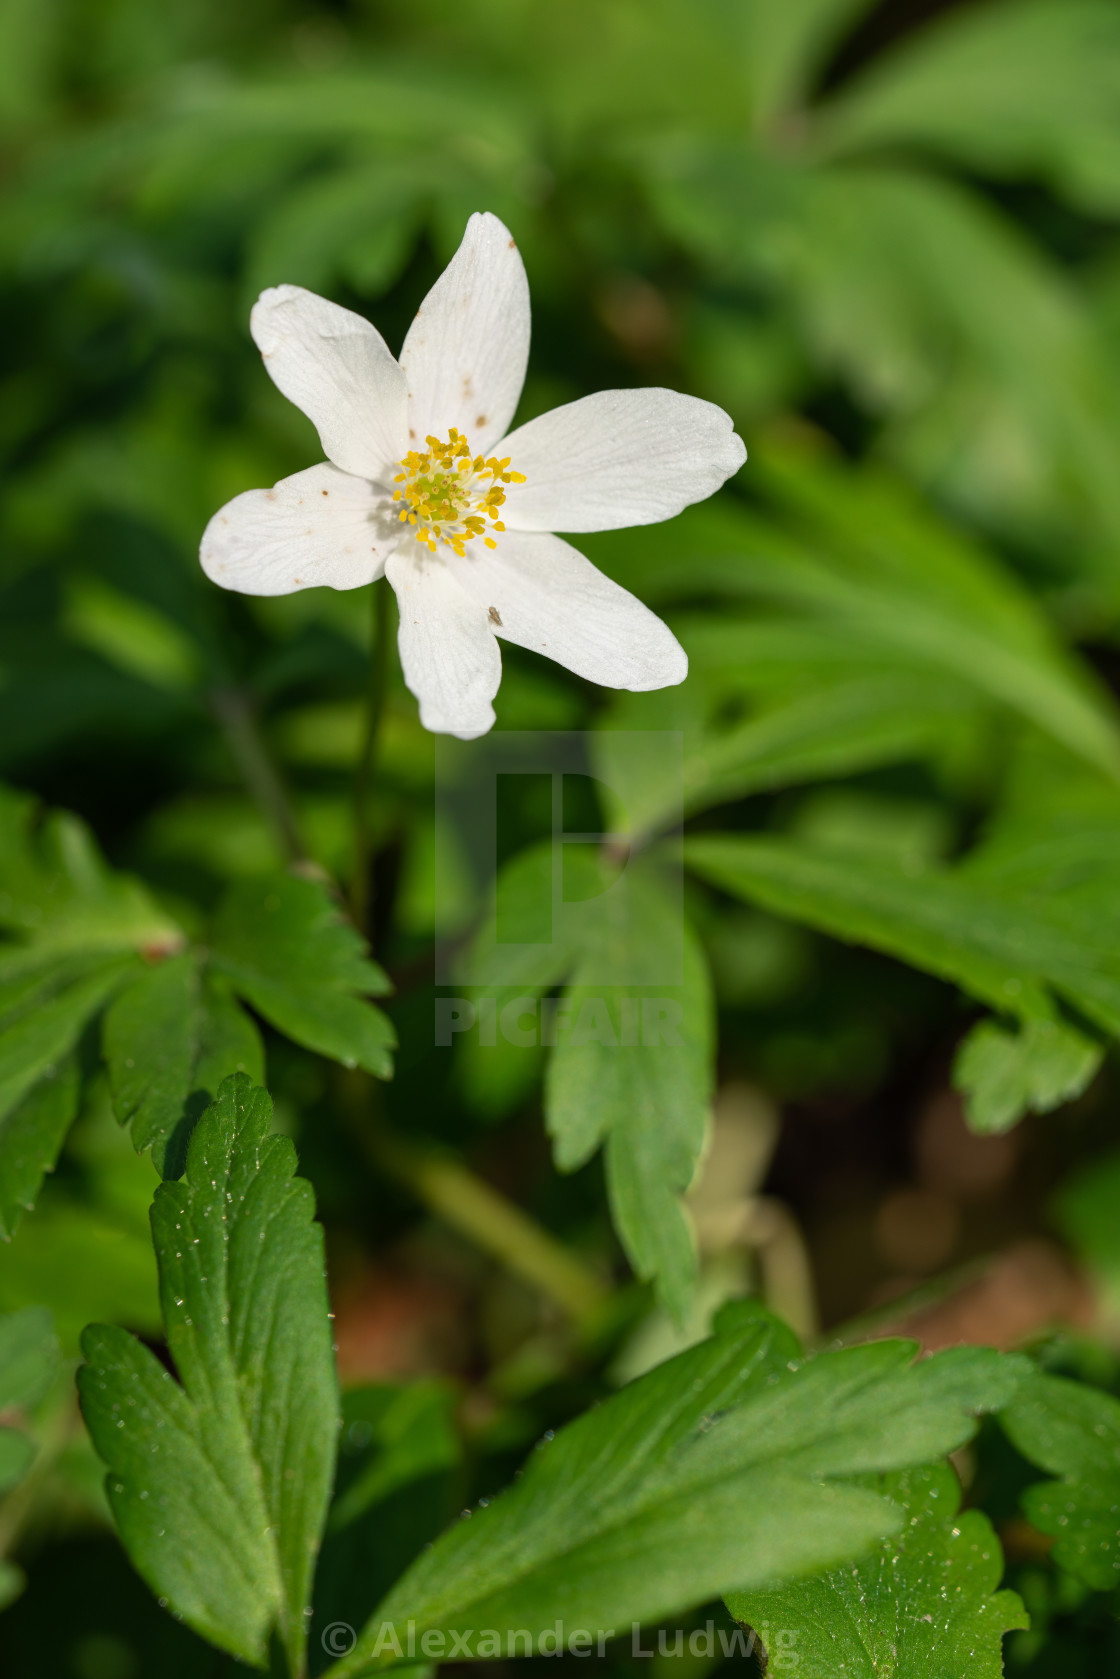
[393,426,526,556]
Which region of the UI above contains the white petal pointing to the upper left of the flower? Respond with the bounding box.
[249,285,408,479]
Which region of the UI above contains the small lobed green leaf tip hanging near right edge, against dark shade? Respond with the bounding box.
[952,1021,1103,1133]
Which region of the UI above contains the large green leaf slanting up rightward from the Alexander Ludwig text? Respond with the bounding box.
[331,1306,1026,1679]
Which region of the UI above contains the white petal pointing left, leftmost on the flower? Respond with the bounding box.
[200,462,401,594]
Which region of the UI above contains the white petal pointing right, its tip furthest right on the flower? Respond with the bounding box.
[499,390,747,531]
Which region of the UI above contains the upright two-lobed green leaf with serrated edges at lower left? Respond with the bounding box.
[79,1075,338,1674]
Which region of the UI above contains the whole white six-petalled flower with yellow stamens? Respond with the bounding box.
[201,215,746,739]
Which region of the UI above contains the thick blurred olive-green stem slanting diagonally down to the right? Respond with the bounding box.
[351,1105,608,1326]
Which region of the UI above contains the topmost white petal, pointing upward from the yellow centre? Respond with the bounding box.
[401,213,529,452]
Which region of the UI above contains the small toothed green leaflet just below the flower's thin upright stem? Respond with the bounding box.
[212,875,396,1078]
